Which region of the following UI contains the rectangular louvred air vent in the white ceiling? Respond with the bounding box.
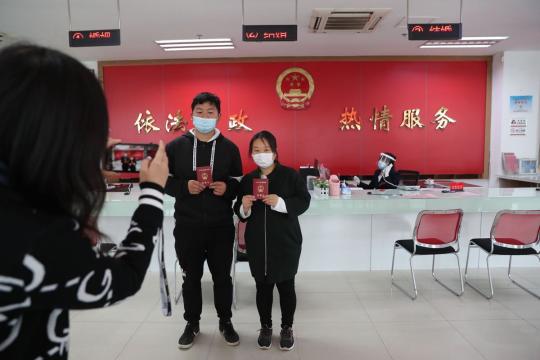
[309,9,390,33]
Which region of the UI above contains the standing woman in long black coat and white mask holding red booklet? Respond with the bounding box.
[235,131,311,350]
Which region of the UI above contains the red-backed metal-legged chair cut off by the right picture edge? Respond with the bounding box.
[465,210,540,299]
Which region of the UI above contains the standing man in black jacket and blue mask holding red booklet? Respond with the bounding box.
[166,92,242,349]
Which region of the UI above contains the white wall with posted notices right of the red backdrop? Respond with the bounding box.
[490,51,540,186]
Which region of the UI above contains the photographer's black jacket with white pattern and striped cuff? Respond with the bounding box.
[0,183,163,360]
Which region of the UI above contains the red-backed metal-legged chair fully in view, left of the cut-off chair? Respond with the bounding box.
[390,209,464,300]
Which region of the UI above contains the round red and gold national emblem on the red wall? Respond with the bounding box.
[276,67,315,110]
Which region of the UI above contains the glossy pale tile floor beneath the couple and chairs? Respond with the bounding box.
[70,268,540,360]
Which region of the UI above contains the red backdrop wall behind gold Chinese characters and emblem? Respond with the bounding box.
[103,60,487,174]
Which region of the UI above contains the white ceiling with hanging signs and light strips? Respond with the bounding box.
[0,0,540,60]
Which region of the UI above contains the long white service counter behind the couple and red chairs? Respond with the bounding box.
[99,187,540,271]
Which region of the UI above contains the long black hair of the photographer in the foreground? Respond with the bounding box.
[0,44,109,236]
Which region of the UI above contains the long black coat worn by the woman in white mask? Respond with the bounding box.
[234,164,311,283]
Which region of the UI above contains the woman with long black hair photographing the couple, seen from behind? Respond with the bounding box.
[0,44,169,360]
